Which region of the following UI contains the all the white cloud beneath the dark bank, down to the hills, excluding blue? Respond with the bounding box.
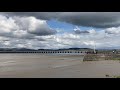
[0,15,120,49]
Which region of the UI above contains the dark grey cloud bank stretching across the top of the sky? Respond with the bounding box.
[2,12,120,28]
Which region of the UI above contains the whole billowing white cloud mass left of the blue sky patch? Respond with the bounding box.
[0,15,56,38]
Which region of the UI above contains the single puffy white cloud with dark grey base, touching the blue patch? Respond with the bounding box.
[14,16,56,36]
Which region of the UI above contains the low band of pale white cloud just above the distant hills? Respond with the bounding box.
[0,28,120,49]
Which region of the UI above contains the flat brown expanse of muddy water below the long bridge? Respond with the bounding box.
[0,53,120,78]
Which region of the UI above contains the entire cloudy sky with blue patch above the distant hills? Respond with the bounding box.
[0,12,120,49]
